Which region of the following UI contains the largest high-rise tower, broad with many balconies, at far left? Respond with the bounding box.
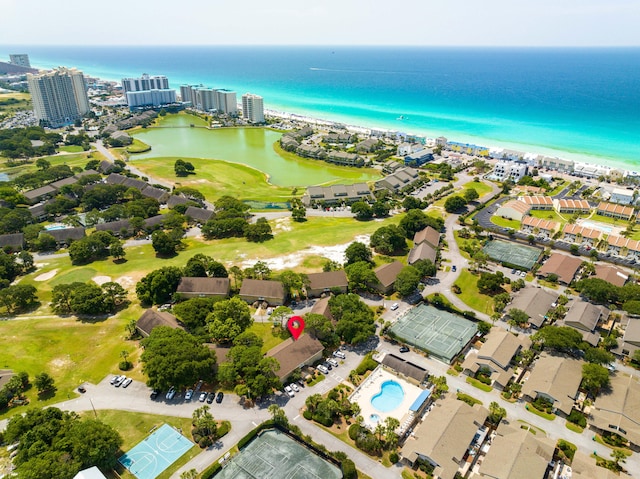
[27,67,90,128]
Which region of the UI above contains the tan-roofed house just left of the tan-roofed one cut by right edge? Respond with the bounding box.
[522,353,584,417]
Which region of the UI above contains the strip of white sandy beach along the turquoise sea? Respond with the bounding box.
[27,57,640,173]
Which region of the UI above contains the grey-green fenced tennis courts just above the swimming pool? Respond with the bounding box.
[391,304,477,363]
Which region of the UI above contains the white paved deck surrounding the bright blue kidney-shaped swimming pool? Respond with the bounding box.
[349,366,422,429]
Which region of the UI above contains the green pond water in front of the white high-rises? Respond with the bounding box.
[131,115,380,186]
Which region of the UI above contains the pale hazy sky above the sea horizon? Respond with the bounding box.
[0,0,640,46]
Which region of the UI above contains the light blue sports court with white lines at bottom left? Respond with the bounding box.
[118,424,193,479]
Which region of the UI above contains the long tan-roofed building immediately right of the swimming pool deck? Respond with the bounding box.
[400,396,488,479]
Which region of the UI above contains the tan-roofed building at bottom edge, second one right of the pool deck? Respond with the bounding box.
[478,423,556,479]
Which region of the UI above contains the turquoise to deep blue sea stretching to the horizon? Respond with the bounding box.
[5,46,640,169]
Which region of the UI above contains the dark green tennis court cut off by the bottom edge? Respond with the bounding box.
[216,429,342,479]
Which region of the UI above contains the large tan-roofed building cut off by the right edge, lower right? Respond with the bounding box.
[589,372,640,450]
